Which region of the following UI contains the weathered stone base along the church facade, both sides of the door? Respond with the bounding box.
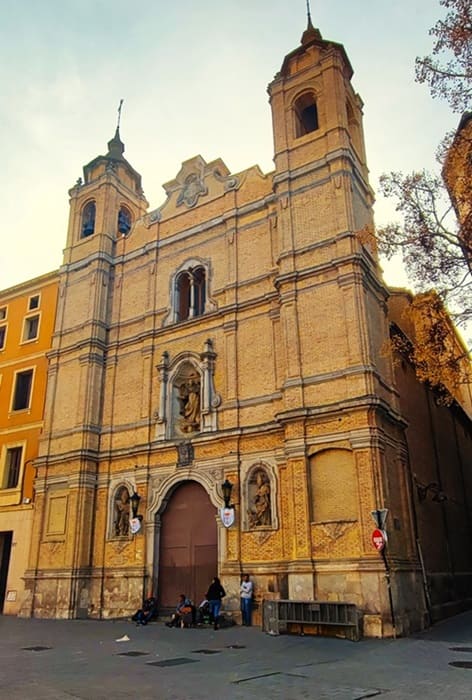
[18,560,472,638]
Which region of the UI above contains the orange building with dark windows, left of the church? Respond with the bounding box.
[0,273,58,614]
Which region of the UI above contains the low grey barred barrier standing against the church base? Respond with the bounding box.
[262,600,360,641]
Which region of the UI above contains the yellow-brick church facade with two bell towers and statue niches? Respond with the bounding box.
[16,22,472,636]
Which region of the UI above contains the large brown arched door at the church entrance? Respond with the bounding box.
[157,481,218,608]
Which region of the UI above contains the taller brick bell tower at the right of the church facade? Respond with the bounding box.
[268,14,403,600]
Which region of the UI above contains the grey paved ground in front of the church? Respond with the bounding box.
[0,612,472,700]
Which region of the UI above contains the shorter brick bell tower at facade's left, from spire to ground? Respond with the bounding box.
[27,124,148,618]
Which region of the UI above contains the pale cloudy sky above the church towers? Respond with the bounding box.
[0,0,459,289]
